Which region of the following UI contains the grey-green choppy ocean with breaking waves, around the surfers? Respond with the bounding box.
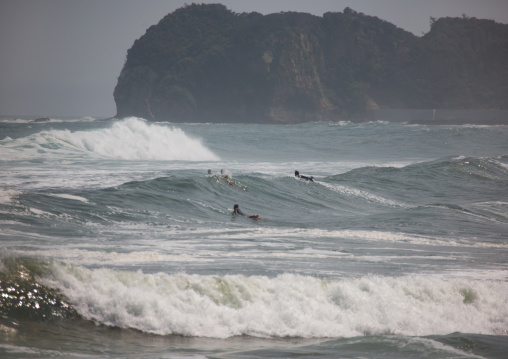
[0,116,508,359]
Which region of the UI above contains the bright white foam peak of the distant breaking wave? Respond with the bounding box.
[46,117,219,161]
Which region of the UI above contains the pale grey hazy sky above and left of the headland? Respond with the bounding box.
[0,0,508,117]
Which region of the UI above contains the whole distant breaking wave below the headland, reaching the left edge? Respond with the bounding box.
[0,117,219,161]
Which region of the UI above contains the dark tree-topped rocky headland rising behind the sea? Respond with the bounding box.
[114,4,508,123]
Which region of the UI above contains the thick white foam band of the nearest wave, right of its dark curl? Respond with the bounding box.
[46,265,508,338]
